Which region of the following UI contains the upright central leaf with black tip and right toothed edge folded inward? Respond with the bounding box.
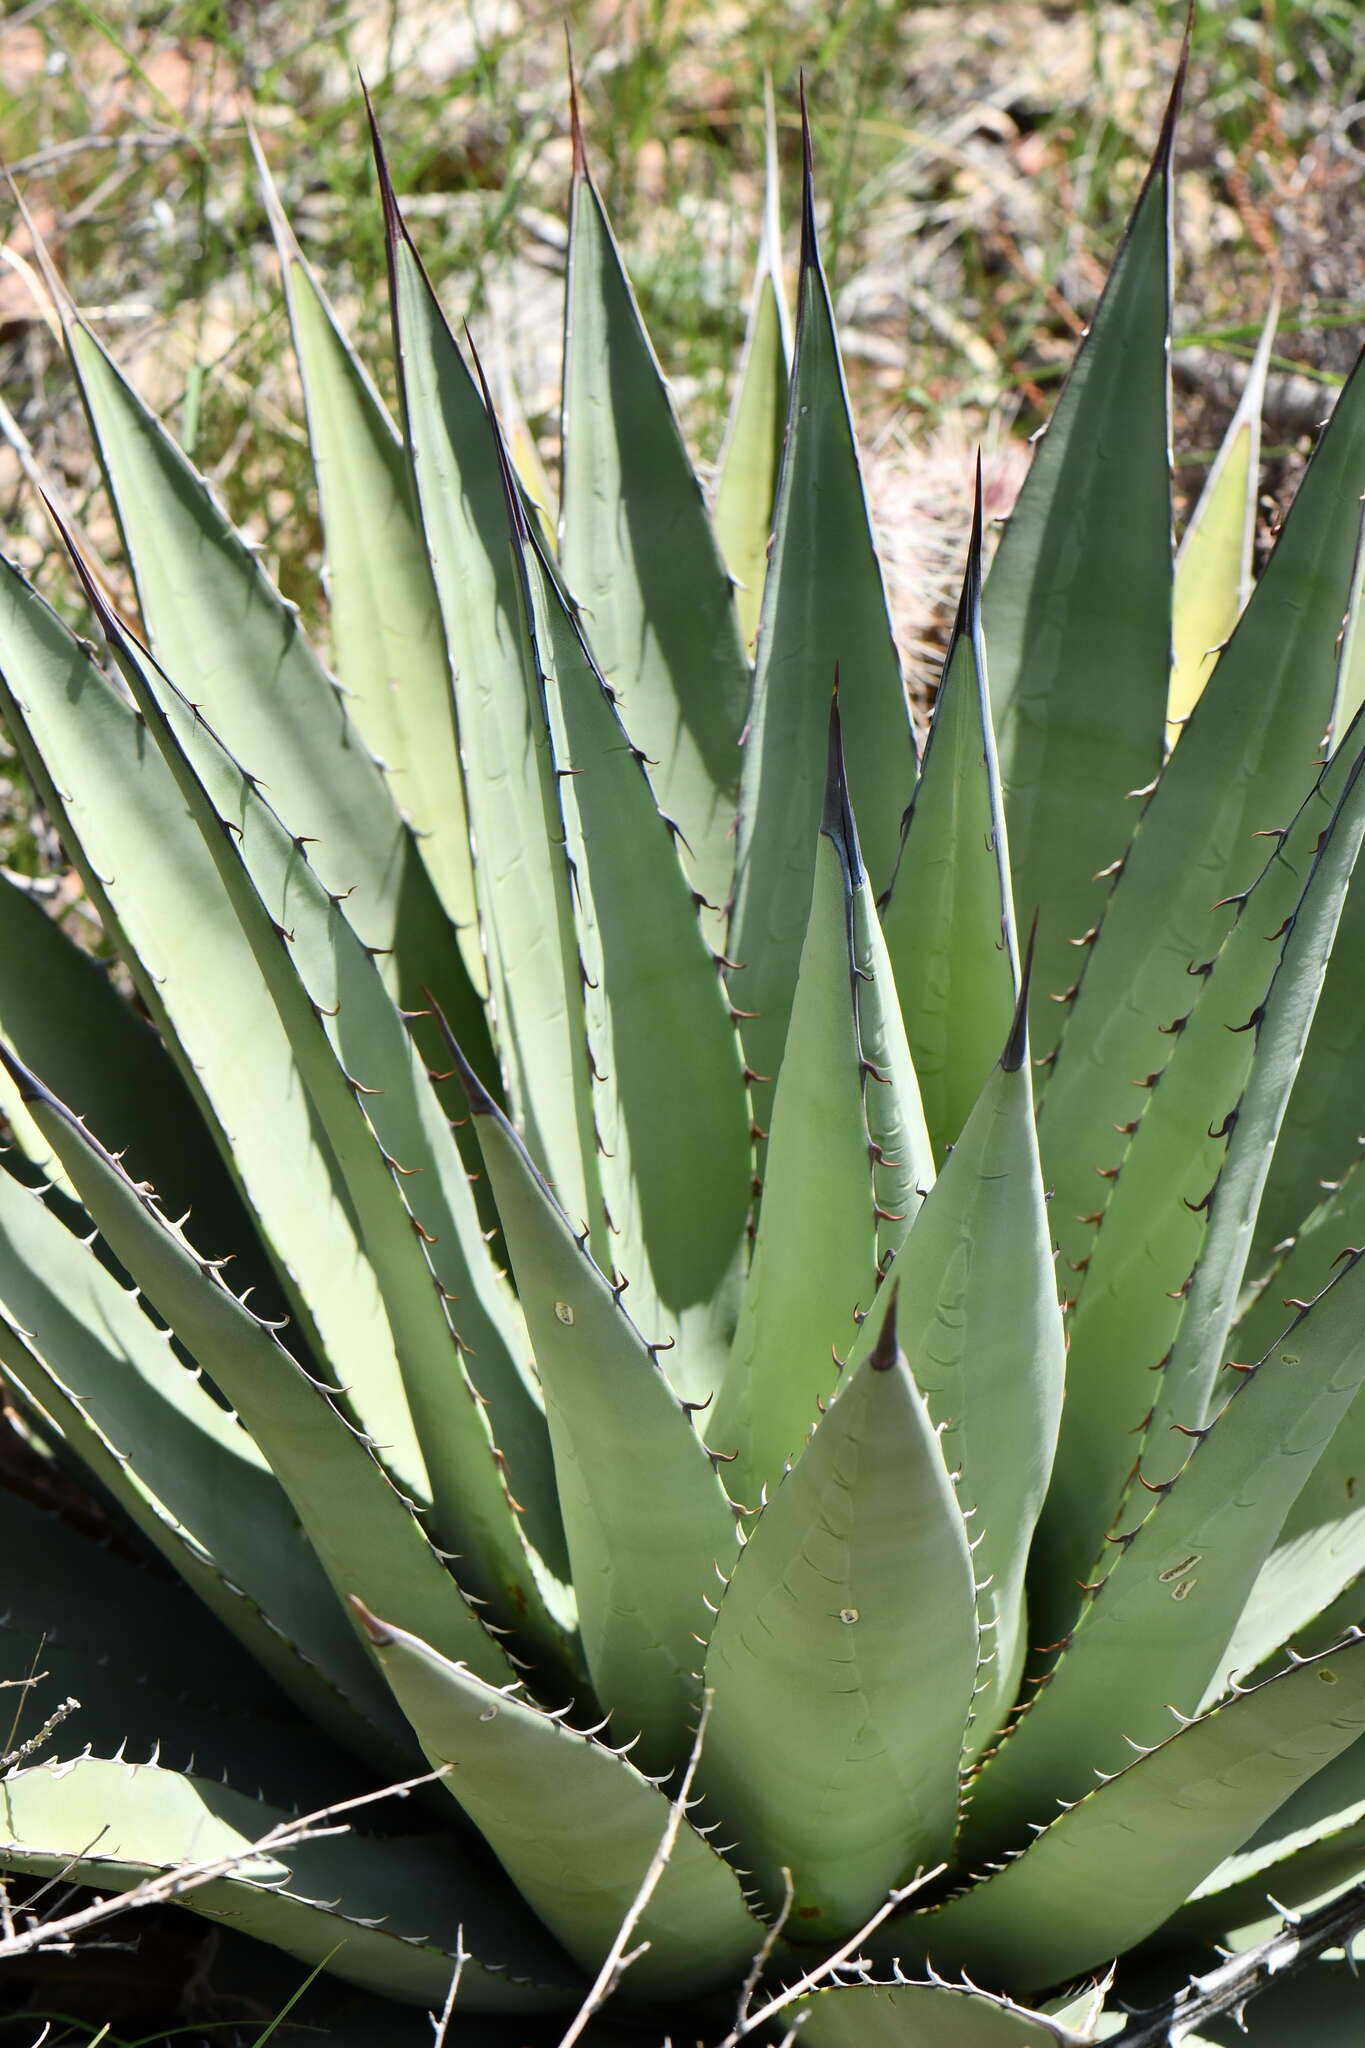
[706,705,933,1505]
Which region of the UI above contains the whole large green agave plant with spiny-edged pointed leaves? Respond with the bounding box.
[0,48,1365,2048]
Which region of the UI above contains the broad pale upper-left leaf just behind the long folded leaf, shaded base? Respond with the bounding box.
[68,324,487,1063]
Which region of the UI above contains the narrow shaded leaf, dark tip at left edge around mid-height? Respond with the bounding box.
[6,1057,517,1677]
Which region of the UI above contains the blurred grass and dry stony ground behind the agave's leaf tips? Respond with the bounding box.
[0,0,1365,870]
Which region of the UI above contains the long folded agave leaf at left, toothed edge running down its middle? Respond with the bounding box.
[68,548,563,1630]
